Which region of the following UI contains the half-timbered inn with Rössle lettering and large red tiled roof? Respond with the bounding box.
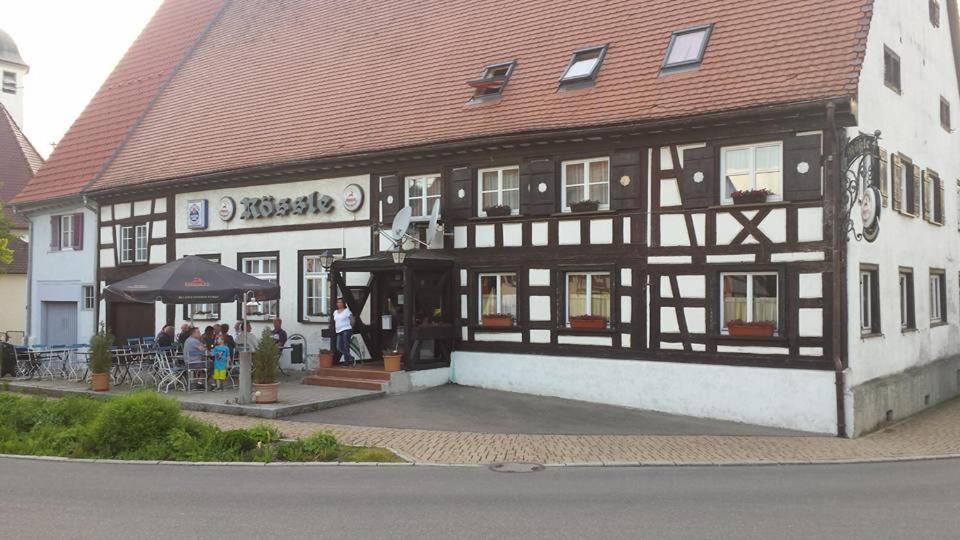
[16,0,960,435]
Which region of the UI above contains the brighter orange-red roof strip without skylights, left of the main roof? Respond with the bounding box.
[14,0,224,204]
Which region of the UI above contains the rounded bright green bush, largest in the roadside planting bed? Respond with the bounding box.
[86,391,182,457]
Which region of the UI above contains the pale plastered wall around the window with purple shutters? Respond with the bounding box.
[26,203,97,343]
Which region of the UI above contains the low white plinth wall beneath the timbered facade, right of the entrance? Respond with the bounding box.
[450,351,837,433]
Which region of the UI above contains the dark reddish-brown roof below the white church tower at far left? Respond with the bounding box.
[0,104,43,228]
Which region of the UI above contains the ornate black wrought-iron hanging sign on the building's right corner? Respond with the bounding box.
[839,131,881,242]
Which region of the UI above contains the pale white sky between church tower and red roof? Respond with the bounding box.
[0,0,162,157]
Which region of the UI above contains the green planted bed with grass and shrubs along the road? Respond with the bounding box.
[0,391,402,463]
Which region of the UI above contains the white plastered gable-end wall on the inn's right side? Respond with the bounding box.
[847,0,960,386]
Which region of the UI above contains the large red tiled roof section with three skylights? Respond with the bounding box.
[91,0,872,190]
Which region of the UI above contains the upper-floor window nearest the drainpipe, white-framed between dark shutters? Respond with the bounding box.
[720,142,783,204]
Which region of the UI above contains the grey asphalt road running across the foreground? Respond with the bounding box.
[0,459,960,540]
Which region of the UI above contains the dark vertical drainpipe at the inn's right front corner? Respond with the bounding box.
[824,103,847,438]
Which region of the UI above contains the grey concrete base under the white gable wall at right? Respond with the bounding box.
[850,355,960,437]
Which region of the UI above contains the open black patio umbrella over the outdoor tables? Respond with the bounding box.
[106,257,280,304]
